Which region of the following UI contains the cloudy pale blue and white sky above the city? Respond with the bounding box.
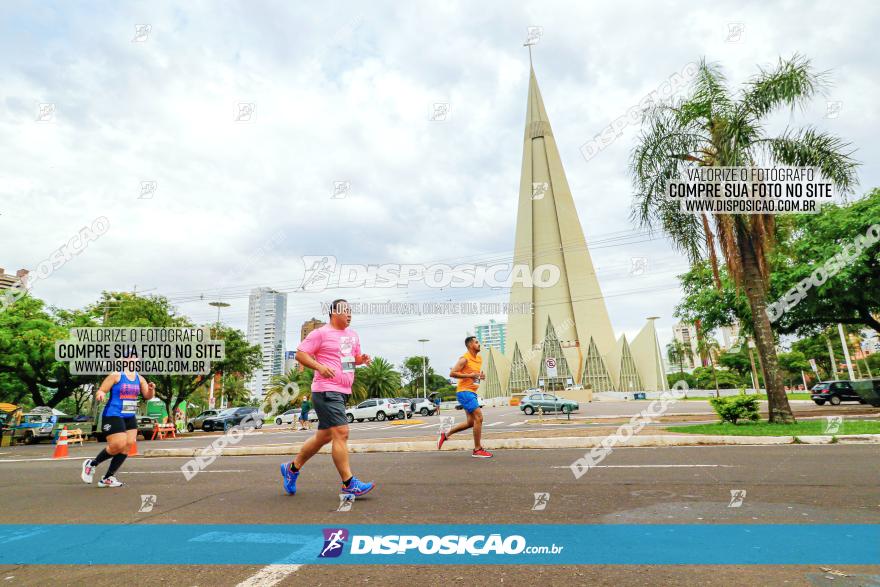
[0,1,880,371]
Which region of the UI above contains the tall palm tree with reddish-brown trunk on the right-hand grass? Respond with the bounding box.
[631,55,857,423]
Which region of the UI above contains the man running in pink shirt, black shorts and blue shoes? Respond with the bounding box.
[281,300,375,497]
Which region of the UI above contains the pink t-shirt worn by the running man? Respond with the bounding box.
[296,324,361,393]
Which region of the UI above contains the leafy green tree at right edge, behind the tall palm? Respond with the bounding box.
[771,188,880,335]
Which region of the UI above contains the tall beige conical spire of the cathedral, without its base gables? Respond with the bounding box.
[508,60,618,390]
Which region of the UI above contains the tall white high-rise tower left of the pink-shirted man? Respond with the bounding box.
[247,287,287,399]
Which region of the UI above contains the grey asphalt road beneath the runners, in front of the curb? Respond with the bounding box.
[0,445,880,586]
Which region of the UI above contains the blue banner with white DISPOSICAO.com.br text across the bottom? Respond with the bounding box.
[0,516,880,565]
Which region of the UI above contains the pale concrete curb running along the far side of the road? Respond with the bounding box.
[143,434,880,457]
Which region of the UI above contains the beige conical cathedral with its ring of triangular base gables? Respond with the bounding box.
[481,58,667,398]
